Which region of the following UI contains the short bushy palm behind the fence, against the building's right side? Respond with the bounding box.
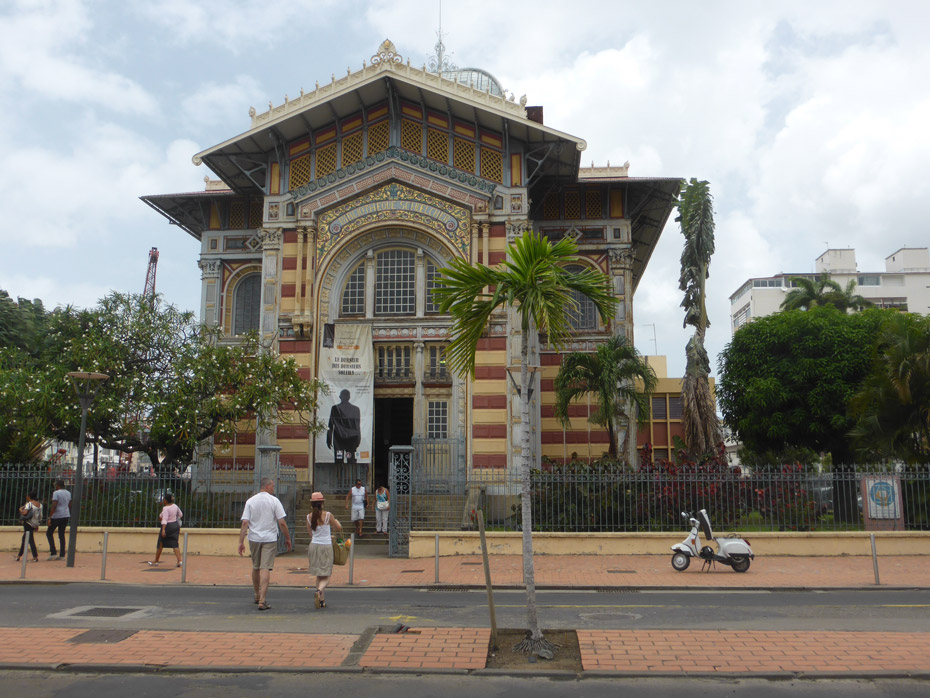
[555,335,657,458]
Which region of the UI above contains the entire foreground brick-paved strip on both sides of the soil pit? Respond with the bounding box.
[0,628,930,679]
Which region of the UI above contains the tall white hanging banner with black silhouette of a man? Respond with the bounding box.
[316,324,375,464]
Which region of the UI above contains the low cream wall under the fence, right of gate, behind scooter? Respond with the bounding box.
[410,531,930,558]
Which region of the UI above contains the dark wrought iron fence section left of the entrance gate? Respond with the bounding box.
[0,465,297,530]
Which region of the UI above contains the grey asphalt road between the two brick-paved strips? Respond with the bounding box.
[0,584,930,634]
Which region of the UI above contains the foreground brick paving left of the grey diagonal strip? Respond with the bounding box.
[0,628,356,668]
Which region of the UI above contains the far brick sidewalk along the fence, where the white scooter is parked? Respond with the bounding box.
[0,553,930,589]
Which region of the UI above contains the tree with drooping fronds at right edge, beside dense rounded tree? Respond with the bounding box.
[850,313,930,465]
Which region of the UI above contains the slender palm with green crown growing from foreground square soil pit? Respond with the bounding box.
[433,230,616,652]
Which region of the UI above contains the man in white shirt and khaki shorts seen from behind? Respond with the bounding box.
[239,477,291,611]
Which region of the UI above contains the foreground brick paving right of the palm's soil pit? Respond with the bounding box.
[578,630,930,674]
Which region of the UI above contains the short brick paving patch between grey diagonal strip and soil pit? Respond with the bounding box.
[359,628,491,669]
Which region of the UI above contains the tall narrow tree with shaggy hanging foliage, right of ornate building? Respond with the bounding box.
[675,178,723,458]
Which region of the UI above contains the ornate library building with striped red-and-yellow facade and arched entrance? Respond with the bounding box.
[143,41,679,487]
